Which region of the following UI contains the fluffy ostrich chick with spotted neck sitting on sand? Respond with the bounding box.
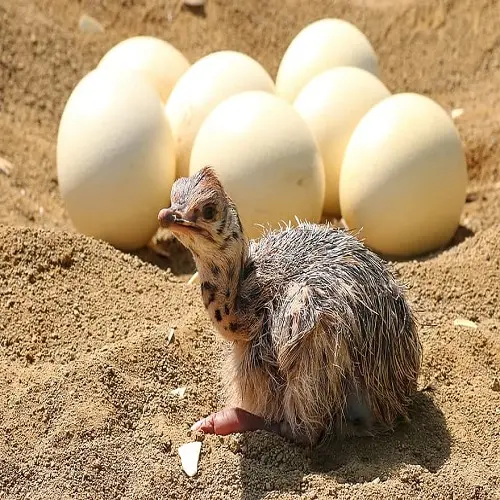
[158,167,421,445]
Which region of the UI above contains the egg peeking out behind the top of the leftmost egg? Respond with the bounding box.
[99,36,190,103]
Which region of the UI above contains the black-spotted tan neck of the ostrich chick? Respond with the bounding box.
[195,233,248,342]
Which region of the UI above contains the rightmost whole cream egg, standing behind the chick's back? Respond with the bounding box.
[339,93,467,258]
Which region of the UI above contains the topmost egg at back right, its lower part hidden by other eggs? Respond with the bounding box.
[276,18,379,102]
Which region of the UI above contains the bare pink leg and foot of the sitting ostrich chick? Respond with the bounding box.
[191,408,280,436]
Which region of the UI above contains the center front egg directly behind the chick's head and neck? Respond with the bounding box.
[190,91,325,238]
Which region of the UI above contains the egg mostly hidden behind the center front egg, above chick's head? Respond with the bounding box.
[165,50,274,177]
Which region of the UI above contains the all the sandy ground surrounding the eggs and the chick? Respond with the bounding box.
[0,0,500,499]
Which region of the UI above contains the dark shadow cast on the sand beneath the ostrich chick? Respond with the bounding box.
[236,392,451,500]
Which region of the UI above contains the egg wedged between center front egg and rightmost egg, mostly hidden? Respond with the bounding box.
[294,66,391,217]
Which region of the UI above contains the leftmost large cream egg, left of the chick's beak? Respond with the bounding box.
[57,69,175,251]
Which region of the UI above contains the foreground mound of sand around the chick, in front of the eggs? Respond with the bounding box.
[0,226,500,498]
